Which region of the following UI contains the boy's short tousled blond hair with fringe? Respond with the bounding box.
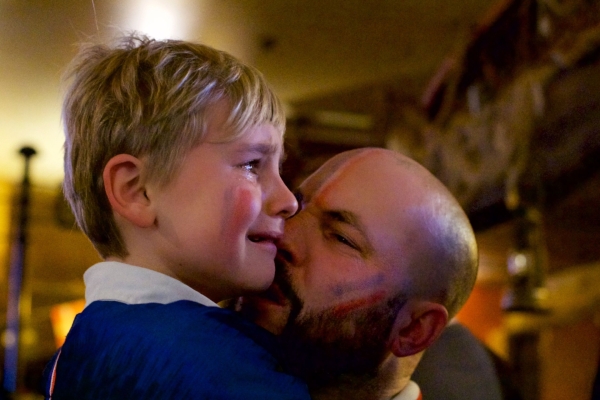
[63,34,285,258]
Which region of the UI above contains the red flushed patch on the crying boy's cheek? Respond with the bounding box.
[221,187,261,243]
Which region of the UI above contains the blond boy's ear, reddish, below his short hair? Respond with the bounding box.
[102,154,155,228]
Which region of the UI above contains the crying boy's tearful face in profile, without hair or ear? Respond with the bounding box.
[145,105,298,301]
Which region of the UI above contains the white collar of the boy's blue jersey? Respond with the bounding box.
[83,261,218,307]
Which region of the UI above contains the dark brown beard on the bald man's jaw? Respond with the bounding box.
[277,272,406,390]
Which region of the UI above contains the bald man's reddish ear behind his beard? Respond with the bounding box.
[388,300,448,357]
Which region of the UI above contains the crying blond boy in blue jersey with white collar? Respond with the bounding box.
[46,36,308,400]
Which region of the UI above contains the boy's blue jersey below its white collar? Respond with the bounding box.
[49,301,308,399]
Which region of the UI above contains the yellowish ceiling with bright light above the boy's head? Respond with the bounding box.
[0,0,494,187]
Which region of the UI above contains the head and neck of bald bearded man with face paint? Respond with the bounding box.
[241,149,477,400]
